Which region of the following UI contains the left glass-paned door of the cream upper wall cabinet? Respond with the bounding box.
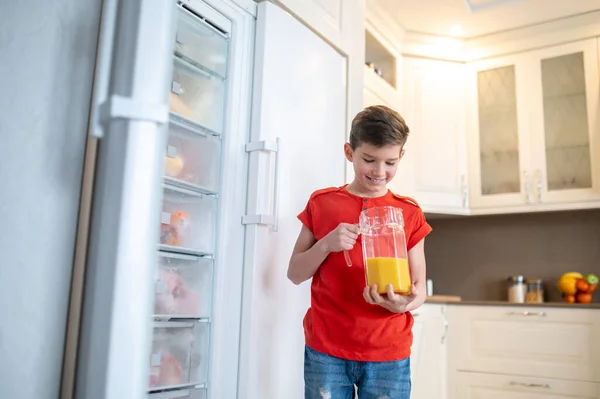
[467,55,532,208]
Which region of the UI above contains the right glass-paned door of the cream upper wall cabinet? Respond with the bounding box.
[528,39,600,204]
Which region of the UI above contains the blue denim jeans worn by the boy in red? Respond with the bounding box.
[304,346,412,399]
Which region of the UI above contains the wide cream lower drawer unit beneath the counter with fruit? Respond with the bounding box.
[448,305,600,399]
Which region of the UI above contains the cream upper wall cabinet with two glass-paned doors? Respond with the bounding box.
[467,39,600,213]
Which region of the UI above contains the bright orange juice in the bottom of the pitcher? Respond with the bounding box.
[365,257,411,295]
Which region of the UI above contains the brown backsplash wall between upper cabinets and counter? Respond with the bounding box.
[425,210,600,302]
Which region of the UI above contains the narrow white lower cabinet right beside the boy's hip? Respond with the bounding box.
[410,304,448,399]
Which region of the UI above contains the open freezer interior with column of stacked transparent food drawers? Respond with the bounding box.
[148,2,231,399]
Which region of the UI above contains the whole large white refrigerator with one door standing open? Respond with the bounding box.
[62,0,347,399]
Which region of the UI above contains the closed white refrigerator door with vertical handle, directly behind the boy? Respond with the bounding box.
[232,2,347,399]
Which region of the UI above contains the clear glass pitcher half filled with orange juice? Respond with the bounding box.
[359,206,412,295]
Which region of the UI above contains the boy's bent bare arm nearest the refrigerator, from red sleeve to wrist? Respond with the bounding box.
[287,225,329,285]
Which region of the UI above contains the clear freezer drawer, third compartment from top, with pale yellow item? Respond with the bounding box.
[165,120,221,193]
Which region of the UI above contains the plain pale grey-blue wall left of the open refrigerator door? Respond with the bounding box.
[0,0,101,399]
